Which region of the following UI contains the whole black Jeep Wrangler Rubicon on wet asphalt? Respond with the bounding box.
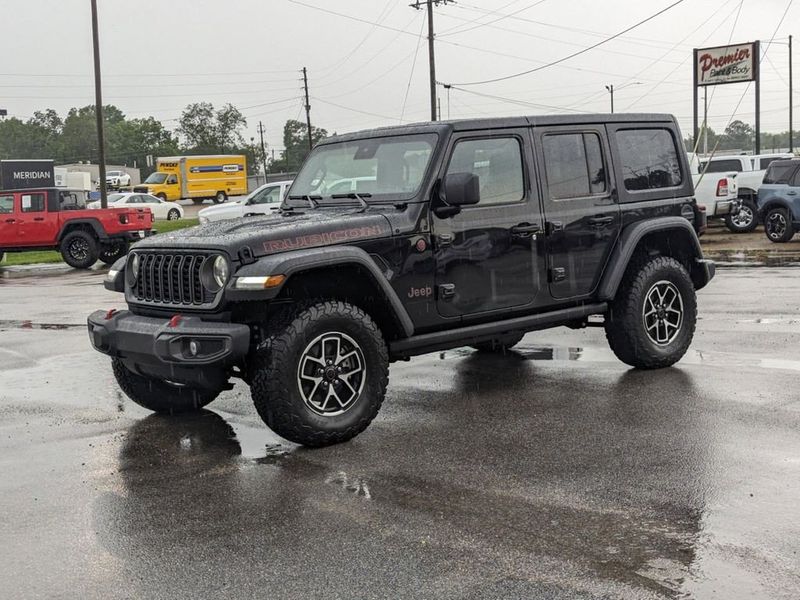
[88,114,714,446]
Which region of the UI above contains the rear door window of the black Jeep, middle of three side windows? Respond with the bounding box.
[542,133,606,200]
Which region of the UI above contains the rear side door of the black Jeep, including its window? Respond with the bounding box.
[534,125,621,299]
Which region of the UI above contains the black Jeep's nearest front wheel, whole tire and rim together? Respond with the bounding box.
[250,301,389,446]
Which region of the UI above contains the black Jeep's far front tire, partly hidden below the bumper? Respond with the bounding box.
[111,358,219,415]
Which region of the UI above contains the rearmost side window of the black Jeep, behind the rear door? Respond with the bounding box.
[617,129,683,191]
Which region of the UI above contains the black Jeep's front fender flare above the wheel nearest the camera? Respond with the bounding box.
[225,246,414,337]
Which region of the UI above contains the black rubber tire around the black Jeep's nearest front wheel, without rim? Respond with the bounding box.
[249,300,389,447]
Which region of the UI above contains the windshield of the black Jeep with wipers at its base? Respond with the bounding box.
[289,134,437,201]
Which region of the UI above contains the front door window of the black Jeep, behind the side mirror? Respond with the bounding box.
[447,137,525,206]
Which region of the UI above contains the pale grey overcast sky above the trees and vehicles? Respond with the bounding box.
[0,0,800,154]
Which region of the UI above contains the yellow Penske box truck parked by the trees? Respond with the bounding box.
[133,154,247,204]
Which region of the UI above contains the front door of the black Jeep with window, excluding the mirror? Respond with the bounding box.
[432,129,544,317]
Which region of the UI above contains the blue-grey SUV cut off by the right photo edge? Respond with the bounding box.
[758,158,800,243]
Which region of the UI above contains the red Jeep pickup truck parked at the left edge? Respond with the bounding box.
[0,188,153,269]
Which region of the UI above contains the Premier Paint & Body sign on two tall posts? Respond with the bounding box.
[692,41,761,154]
